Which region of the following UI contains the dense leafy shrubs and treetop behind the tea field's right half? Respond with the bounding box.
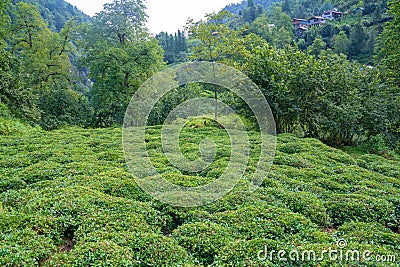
[189,13,400,151]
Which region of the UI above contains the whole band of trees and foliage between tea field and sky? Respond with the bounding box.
[0,0,400,149]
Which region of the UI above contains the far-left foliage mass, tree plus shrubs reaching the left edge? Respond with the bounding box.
[0,2,89,129]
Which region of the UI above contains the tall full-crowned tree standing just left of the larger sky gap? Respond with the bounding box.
[81,0,163,127]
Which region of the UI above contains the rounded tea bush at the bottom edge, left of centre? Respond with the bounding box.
[48,230,192,267]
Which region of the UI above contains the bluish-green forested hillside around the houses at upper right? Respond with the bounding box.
[219,0,392,65]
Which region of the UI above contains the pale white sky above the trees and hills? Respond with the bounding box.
[66,0,241,34]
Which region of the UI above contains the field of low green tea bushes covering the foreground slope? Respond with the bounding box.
[0,127,400,266]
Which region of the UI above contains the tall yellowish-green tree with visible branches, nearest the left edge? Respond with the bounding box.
[9,2,88,129]
